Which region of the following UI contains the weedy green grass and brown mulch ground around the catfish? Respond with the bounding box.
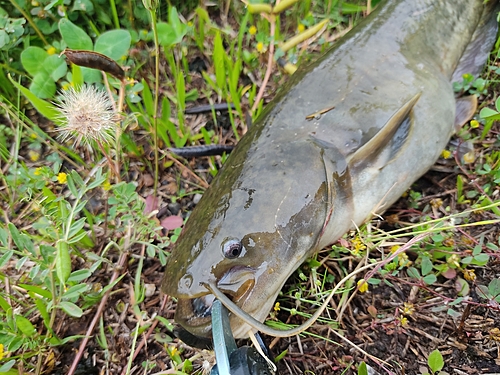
[0,1,500,374]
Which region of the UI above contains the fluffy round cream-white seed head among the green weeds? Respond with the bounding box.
[56,85,117,145]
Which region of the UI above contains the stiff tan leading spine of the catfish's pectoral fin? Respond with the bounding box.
[347,92,421,167]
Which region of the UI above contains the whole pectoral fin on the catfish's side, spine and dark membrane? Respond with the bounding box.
[347,93,421,168]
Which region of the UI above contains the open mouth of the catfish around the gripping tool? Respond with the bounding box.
[175,267,255,347]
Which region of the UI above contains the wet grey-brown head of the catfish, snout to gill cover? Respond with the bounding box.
[162,136,350,344]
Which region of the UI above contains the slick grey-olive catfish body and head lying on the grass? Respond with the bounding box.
[162,0,498,337]
